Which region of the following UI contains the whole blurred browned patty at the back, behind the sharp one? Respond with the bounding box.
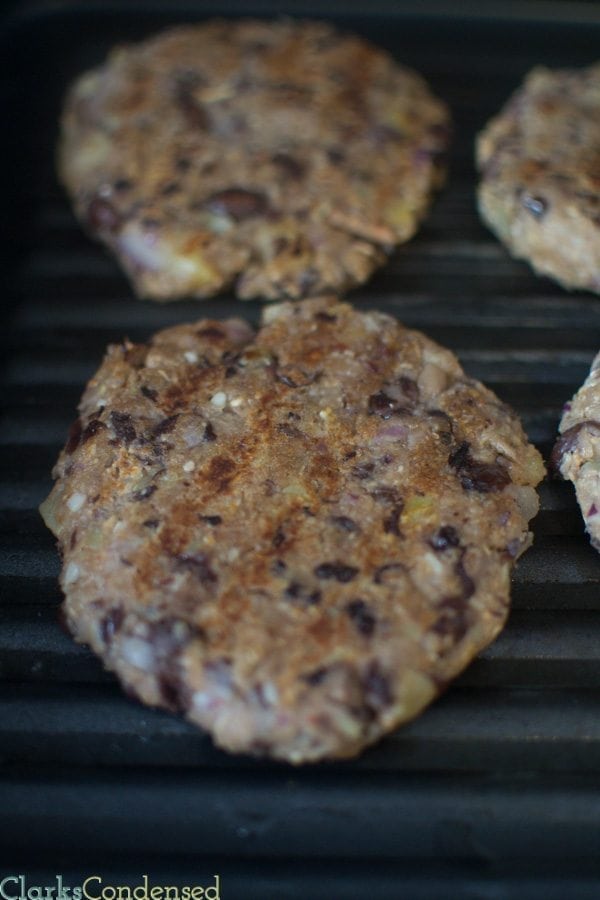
[58,20,449,300]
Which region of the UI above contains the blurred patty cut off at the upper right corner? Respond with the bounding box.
[477,64,600,293]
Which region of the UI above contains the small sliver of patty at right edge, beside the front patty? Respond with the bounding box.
[552,353,600,551]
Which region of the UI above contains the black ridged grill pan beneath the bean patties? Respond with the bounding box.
[0,0,600,900]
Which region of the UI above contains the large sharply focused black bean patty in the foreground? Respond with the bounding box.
[37,297,544,763]
